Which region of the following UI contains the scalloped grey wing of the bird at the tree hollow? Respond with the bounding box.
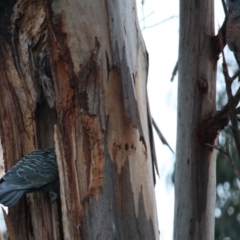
[3,149,58,189]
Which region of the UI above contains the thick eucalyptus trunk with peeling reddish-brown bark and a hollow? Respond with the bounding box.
[0,0,159,240]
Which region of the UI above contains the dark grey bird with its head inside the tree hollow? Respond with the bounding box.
[0,148,58,207]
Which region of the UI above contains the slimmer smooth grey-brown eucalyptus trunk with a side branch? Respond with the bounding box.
[174,0,217,240]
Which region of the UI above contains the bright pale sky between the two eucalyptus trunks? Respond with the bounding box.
[137,0,179,240]
